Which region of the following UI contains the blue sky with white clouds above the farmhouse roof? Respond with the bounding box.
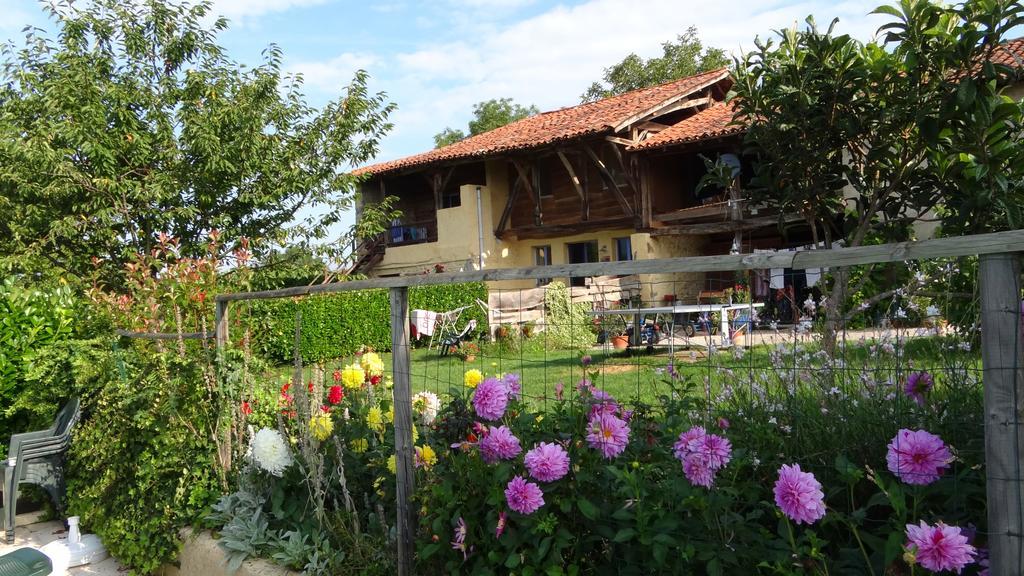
[0,0,881,233]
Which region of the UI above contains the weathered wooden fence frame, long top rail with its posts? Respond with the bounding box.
[207,230,1024,576]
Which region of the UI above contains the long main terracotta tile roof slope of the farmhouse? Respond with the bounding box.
[353,69,729,174]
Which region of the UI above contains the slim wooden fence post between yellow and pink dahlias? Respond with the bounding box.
[390,287,415,576]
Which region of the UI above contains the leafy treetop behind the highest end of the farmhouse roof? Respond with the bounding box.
[581,26,729,102]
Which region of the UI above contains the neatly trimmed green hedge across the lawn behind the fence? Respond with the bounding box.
[250,282,487,363]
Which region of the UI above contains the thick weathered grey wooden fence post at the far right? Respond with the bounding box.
[979,254,1024,576]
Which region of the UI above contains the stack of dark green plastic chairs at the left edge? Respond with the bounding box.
[0,398,81,541]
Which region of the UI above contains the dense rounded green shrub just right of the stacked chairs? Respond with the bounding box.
[68,341,229,574]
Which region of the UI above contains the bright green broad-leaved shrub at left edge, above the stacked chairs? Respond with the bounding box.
[0,279,78,455]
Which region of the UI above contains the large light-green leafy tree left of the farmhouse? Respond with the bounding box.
[0,0,393,283]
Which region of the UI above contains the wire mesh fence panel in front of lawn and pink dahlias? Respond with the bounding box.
[216,234,1024,574]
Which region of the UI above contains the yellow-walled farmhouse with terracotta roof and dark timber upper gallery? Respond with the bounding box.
[354,39,1024,301]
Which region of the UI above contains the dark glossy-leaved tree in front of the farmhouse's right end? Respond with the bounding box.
[733,0,1024,345]
